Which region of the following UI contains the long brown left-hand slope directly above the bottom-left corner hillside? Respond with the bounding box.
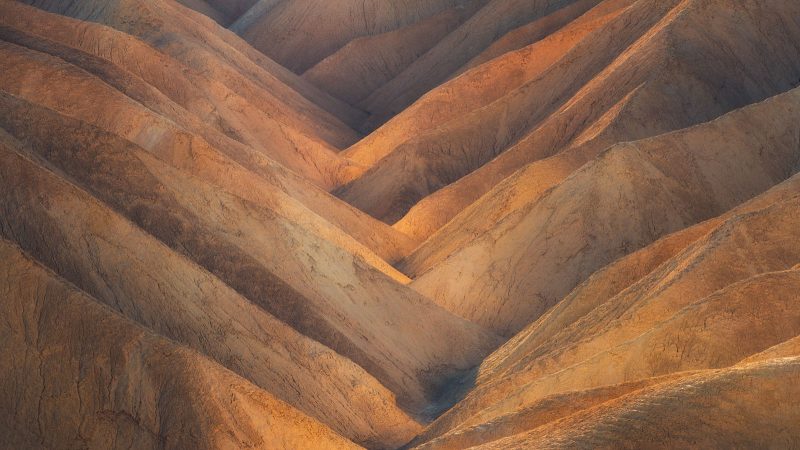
[0,137,416,443]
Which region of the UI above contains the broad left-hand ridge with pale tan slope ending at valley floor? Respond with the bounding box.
[4,30,504,418]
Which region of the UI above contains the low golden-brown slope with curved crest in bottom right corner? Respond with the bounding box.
[477,357,798,449]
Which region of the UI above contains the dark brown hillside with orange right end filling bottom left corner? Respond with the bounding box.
[0,240,355,449]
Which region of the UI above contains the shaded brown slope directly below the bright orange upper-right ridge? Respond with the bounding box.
[337,1,678,221]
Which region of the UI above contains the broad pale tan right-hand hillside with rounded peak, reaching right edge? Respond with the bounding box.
[413,86,800,334]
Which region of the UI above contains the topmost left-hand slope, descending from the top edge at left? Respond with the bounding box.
[21,0,363,130]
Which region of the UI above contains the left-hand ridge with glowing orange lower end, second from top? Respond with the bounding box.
[4,5,353,188]
